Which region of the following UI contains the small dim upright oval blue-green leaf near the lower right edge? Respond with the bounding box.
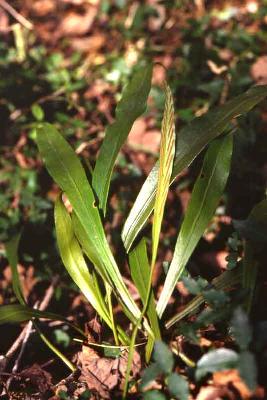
[231,307,252,350]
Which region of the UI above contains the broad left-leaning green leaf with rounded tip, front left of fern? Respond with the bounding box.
[37,123,140,320]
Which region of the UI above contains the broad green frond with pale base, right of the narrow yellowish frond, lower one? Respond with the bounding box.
[157,134,233,317]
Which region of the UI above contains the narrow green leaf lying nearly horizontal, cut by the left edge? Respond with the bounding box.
[0,304,70,324]
